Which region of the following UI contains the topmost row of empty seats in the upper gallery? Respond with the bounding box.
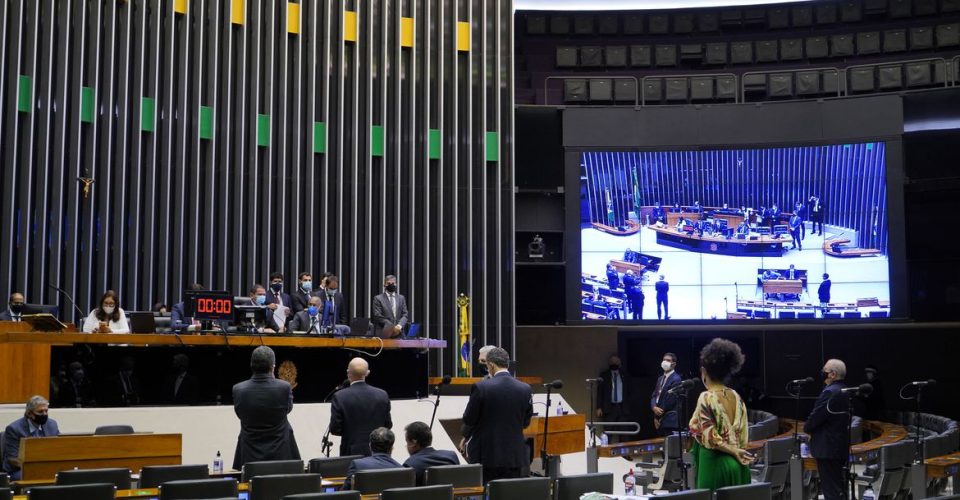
[524,0,960,36]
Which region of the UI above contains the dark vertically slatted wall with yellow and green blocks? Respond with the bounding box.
[0,0,512,373]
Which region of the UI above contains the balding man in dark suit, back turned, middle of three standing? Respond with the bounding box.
[330,358,390,458]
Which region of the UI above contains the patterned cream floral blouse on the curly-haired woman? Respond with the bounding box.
[690,388,749,455]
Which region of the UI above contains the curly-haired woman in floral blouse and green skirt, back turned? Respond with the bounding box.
[690,339,754,490]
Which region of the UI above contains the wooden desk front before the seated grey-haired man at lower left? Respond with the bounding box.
[20,434,183,481]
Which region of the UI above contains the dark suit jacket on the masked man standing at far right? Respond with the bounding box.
[803,382,850,460]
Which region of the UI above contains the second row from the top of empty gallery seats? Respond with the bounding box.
[556,23,960,70]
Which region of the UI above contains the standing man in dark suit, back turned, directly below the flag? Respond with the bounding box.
[461,347,533,483]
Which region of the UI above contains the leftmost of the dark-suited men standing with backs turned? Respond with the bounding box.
[233,345,300,470]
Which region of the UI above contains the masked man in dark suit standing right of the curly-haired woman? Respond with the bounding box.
[803,359,850,500]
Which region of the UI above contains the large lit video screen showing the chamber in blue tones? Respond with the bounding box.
[579,142,890,321]
